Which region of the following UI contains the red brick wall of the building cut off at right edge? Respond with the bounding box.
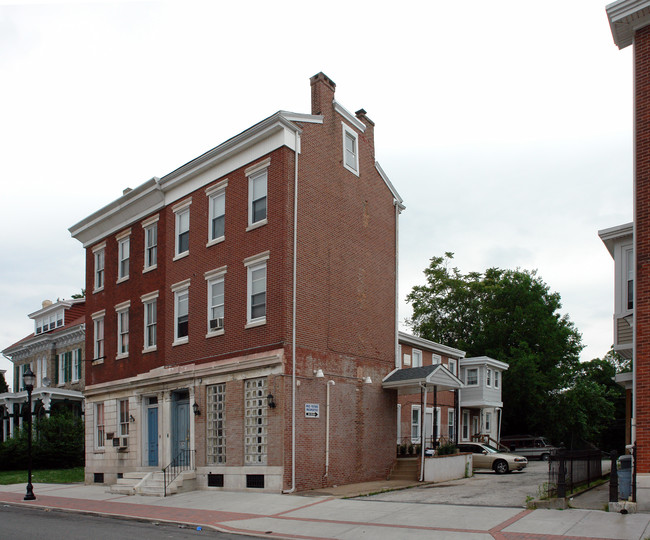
[634,27,650,473]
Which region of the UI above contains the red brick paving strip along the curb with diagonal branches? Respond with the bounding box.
[0,492,615,540]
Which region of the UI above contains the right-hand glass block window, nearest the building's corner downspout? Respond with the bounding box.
[244,377,268,465]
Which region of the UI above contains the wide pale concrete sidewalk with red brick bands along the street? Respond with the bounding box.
[0,482,650,540]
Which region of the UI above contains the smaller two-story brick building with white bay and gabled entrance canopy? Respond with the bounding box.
[384,332,508,454]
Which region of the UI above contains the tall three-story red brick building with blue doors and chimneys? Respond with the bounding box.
[70,73,403,491]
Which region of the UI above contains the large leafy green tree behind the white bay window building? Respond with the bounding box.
[407,253,583,442]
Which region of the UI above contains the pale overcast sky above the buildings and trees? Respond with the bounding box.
[0,0,633,385]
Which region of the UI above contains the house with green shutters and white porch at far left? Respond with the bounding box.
[0,298,85,437]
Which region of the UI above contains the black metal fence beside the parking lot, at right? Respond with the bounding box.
[547,450,603,497]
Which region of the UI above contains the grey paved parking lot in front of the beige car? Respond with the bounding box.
[364,461,548,507]
